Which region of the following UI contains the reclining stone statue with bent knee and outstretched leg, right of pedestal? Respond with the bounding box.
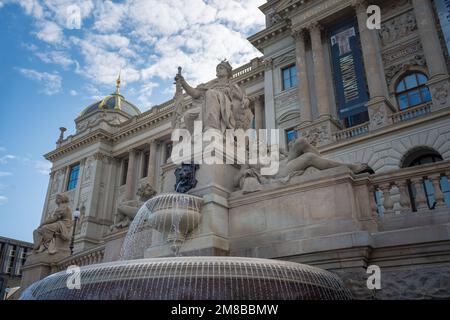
[234,137,374,193]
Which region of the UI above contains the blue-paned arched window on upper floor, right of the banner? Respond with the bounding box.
[395,72,431,110]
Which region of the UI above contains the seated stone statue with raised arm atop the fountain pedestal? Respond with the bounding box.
[175,60,253,133]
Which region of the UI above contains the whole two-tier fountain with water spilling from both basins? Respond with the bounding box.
[21,193,352,300]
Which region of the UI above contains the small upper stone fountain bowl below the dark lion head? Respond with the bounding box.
[146,193,203,235]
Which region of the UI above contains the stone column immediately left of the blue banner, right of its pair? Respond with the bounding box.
[310,23,331,118]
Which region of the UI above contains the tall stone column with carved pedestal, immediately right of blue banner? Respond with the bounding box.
[353,0,395,130]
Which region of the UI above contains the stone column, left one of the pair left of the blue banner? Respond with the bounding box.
[292,30,312,124]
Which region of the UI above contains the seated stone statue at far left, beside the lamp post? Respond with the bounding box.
[33,194,72,254]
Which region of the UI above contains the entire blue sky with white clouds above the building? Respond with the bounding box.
[0,0,265,241]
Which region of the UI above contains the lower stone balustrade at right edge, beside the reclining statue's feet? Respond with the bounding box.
[370,161,450,218]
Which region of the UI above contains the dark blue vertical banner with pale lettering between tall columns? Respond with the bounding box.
[328,21,368,119]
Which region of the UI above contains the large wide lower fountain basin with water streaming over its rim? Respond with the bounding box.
[21,257,352,300]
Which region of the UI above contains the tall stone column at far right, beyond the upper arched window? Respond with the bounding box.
[412,0,450,109]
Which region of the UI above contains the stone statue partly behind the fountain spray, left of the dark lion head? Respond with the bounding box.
[110,182,157,231]
